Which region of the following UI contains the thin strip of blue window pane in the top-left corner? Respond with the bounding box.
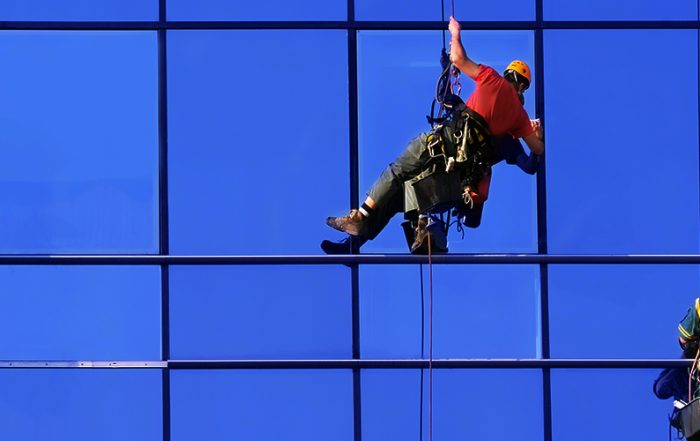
[0,0,158,21]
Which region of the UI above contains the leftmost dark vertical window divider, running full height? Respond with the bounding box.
[157,0,171,441]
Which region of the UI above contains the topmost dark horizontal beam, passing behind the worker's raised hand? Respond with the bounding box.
[0,20,700,31]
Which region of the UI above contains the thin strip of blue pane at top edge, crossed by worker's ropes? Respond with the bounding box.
[355,0,535,21]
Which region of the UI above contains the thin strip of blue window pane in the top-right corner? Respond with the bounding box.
[543,0,698,20]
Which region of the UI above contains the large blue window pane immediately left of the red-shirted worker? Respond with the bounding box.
[168,31,349,254]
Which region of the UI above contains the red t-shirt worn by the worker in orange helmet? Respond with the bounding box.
[467,65,533,138]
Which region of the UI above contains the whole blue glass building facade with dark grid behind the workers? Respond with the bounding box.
[0,0,700,441]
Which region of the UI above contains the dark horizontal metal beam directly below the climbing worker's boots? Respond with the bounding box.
[0,254,700,265]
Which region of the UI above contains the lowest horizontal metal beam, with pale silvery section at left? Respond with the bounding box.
[0,358,692,370]
